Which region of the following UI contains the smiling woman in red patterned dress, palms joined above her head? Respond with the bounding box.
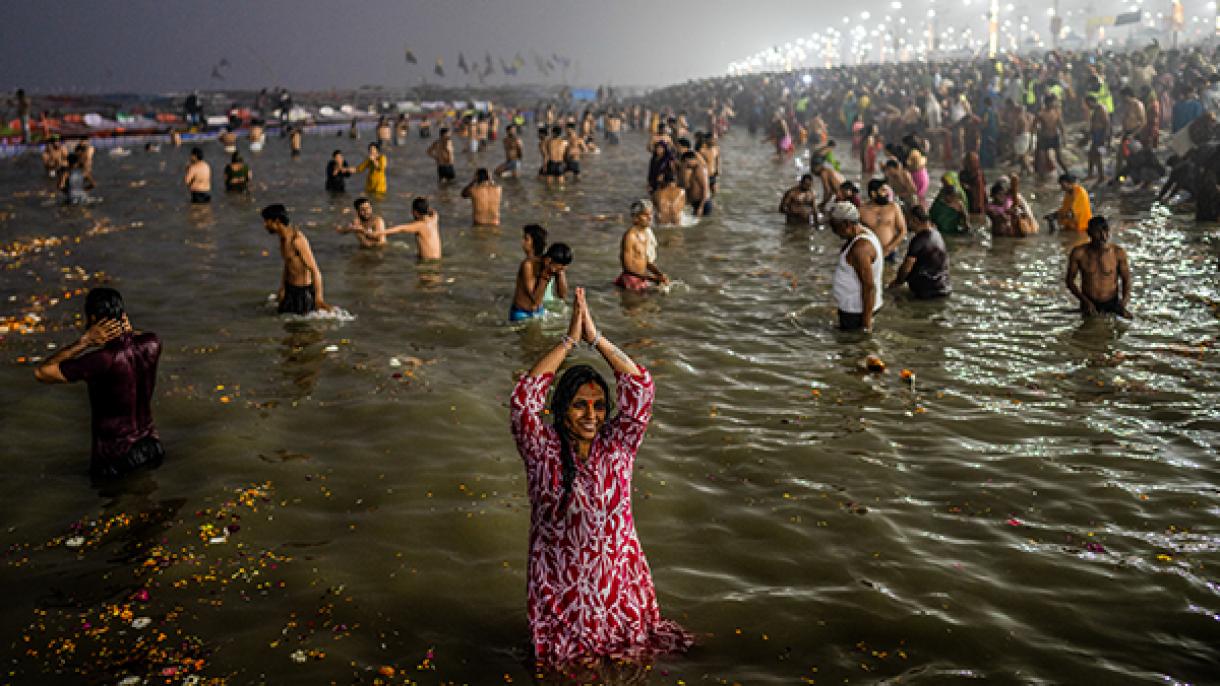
[510,288,693,669]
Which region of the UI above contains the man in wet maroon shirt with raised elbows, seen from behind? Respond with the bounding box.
[34,288,165,478]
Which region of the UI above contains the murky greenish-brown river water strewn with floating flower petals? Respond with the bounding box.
[0,131,1220,684]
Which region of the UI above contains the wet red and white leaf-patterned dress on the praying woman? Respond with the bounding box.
[510,367,693,666]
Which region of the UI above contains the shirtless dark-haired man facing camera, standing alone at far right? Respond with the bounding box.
[1068,216,1131,319]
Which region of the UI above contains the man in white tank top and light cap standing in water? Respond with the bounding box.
[830,203,885,332]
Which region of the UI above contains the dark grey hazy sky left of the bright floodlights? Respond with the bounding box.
[0,0,912,93]
